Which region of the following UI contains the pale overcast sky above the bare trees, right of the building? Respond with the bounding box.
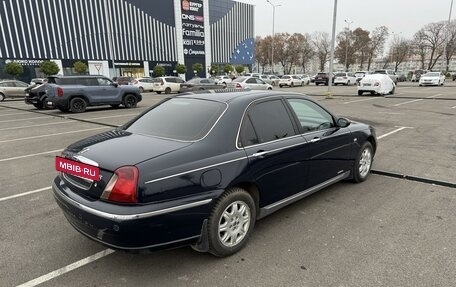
[238,0,456,39]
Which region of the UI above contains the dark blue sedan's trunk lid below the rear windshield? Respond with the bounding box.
[63,130,192,171]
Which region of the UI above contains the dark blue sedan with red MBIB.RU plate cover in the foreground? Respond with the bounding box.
[53,91,377,257]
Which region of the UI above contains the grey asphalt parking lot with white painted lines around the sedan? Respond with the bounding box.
[0,82,456,287]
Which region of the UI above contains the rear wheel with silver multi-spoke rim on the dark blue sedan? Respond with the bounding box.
[207,188,256,257]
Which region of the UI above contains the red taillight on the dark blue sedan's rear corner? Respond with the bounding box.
[101,166,138,203]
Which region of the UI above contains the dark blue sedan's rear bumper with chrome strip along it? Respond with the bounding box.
[52,177,212,250]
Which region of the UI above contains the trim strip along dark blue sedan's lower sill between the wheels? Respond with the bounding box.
[258,170,350,218]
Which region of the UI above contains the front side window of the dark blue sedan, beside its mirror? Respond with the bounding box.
[287,99,335,133]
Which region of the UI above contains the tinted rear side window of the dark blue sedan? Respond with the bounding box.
[240,100,296,146]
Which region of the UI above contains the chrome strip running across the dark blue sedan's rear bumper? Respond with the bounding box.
[53,183,212,221]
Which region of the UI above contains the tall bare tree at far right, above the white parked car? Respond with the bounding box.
[415,21,445,70]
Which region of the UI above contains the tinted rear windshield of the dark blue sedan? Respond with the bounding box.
[126,98,226,141]
